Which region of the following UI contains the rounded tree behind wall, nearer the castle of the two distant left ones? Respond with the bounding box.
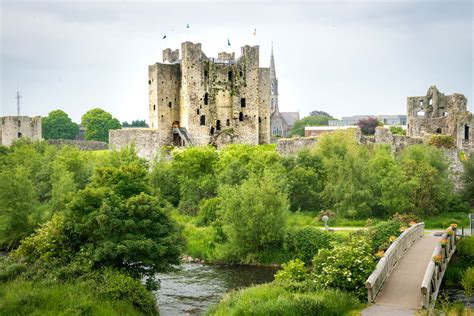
[81,108,122,142]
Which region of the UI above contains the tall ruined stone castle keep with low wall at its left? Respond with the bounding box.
[109,42,294,158]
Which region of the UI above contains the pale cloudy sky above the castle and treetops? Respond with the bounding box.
[0,0,474,122]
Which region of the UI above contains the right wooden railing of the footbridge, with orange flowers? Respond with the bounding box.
[421,227,456,309]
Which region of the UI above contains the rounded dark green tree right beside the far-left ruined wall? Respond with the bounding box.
[41,110,79,139]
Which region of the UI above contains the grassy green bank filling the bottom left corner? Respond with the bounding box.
[0,279,141,316]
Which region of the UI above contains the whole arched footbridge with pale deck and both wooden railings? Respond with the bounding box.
[362,223,456,316]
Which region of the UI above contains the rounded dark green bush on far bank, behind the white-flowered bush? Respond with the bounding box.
[284,226,333,263]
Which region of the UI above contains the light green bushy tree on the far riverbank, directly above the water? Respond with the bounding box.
[219,171,289,259]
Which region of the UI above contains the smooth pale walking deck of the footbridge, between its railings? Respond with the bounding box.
[362,234,440,315]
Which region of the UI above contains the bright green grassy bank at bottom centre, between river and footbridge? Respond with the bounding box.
[208,283,361,316]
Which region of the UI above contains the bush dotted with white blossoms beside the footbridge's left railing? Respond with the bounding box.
[313,241,375,299]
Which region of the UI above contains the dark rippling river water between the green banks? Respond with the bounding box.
[157,263,276,316]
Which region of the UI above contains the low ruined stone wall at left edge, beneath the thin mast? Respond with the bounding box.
[0,116,42,146]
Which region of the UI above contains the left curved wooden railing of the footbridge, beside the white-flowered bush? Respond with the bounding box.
[365,223,425,303]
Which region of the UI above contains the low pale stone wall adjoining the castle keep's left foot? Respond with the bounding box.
[109,128,163,160]
